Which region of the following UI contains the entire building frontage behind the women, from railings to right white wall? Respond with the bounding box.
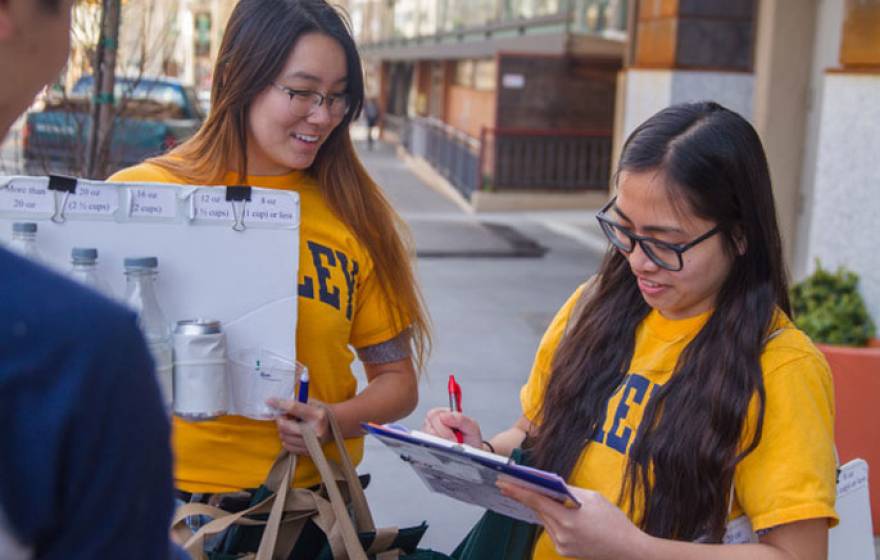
[348,0,880,321]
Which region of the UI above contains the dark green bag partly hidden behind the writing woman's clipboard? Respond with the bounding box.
[452,449,538,560]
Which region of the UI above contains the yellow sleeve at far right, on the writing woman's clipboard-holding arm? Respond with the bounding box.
[734,329,838,531]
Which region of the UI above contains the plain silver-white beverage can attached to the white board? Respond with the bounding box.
[174,319,227,421]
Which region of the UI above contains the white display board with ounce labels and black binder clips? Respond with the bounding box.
[0,176,300,368]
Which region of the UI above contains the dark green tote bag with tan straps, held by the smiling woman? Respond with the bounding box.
[172,409,449,560]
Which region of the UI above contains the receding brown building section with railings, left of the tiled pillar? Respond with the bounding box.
[348,0,628,206]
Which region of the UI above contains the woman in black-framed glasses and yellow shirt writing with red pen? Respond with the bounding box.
[425,103,837,560]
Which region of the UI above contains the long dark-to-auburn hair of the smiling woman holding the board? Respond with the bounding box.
[150,0,430,369]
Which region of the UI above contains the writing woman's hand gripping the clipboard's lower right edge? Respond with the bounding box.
[498,481,647,560]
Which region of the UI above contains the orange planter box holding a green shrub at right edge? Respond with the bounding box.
[817,339,880,535]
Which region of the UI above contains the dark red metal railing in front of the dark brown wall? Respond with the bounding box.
[482,129,612,191]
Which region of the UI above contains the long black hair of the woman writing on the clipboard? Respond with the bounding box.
[532,102,790,541]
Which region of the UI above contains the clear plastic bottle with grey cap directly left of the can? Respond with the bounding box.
[125,257,174,412]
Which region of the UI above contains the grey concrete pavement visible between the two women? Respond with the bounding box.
[350,136,604,552]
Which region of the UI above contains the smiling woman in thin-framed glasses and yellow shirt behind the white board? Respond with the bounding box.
[111,0,428,503]
